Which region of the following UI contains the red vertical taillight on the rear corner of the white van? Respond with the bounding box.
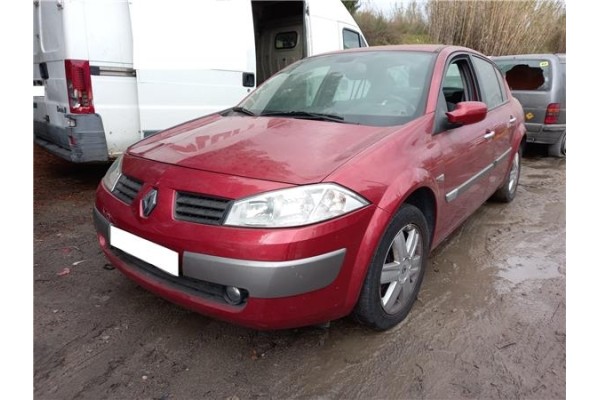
[65,60,94,114]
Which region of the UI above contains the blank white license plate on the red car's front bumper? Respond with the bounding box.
[110,225,179,276]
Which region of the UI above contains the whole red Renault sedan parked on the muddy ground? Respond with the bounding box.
[94,45,525,330]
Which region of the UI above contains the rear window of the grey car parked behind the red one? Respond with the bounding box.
[495,59,552,91]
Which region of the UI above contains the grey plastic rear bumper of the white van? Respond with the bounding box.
[33,114,108,163]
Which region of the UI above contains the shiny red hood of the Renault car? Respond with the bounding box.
[129,115,397,185]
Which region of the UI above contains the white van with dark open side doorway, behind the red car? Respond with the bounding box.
[33,0,367,162]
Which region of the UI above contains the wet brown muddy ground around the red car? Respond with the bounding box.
[33,146,566,400]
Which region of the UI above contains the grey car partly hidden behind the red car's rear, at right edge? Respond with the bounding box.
[491,54,567,157]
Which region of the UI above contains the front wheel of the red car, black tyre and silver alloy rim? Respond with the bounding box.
[354,204,429,330]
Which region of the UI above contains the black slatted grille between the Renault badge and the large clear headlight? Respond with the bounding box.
[175,192,231,225]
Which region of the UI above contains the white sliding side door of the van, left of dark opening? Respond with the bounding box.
[130,0,256,137]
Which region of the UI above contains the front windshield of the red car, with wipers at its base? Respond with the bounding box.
[237,51,434,126]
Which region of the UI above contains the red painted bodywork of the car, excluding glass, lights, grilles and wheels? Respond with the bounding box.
[96,46,525,329]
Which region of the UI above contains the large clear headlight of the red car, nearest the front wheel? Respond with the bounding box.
[224,183,369,228]
